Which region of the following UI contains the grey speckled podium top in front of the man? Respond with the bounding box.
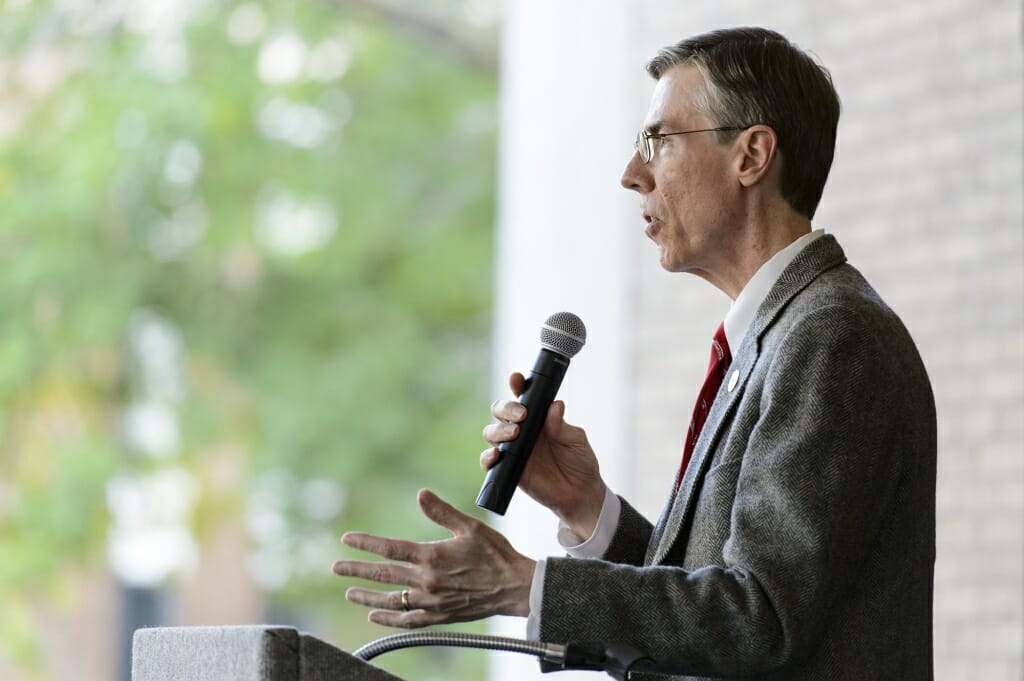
[131,625,402,681]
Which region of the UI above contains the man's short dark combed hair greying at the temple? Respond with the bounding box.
[647,28,841,218]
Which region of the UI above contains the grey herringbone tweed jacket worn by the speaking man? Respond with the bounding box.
[540,236,936,681]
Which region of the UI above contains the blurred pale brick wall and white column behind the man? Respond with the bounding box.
[494,0,1024,681]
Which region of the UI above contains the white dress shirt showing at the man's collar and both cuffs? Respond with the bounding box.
[526,229,824,640]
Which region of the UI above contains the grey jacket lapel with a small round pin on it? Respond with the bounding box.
[646,235,846,565]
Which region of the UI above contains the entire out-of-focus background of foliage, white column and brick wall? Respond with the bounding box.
[0,0,1024,681]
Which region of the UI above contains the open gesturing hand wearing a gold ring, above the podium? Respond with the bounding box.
[332,490,537,629]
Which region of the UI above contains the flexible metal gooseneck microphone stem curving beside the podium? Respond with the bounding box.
[352,632,653,681]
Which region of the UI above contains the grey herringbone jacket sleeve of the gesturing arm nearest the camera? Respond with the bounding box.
[540,306,909,676]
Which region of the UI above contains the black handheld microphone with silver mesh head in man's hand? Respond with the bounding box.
[476,312,587,515]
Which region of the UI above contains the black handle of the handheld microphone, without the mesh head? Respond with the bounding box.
[476,348,569,515]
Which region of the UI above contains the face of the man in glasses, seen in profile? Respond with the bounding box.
[622,65,739,276]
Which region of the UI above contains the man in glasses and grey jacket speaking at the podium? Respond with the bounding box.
[334,29,936,681]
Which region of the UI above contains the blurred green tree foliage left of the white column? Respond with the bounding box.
[0,1,497,678]
